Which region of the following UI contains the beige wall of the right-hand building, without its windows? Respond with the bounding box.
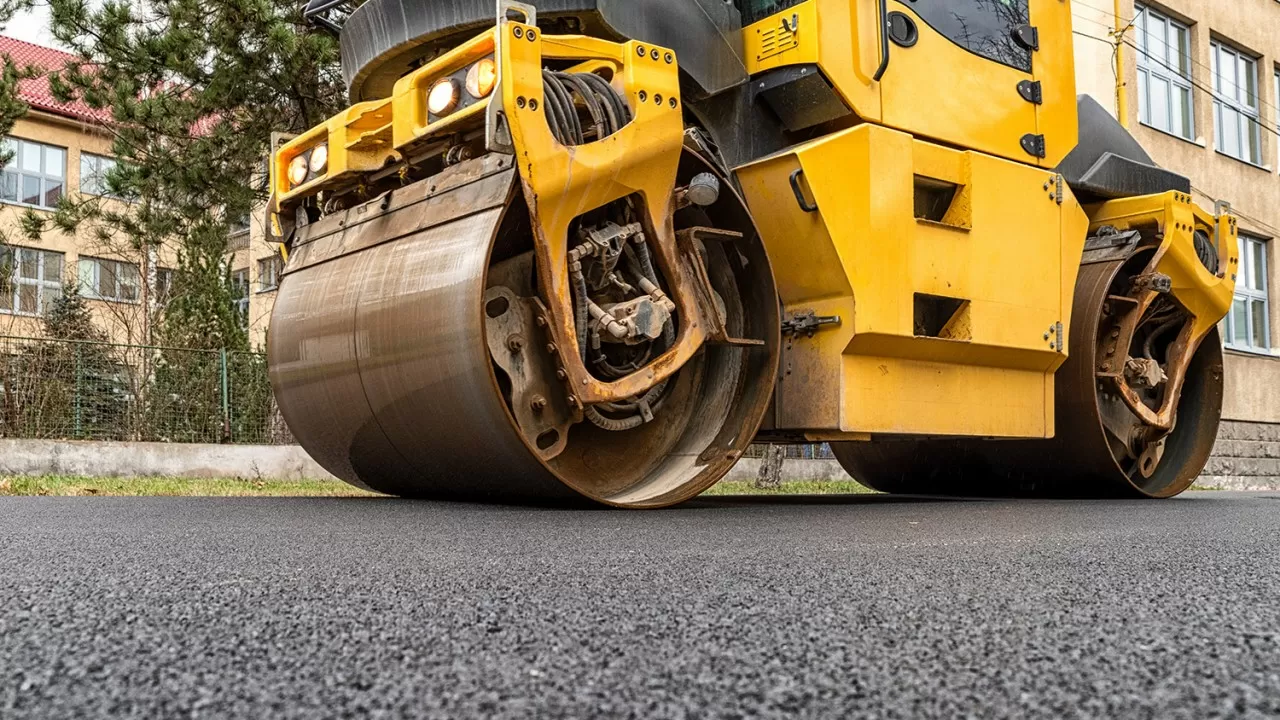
[1071,0,1280,423]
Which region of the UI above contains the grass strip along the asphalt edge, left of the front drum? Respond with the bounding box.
[0,475,374,497]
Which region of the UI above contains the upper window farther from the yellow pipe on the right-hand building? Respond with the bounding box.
[1211,41,1262,165]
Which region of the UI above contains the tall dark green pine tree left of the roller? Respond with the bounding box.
[23,0,346,350]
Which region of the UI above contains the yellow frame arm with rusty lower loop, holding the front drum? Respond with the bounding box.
[498,18,708,405]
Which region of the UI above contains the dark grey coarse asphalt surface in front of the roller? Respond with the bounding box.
[0,492,1280,719]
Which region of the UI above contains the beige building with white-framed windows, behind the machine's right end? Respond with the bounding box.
[1071,0,1280,484]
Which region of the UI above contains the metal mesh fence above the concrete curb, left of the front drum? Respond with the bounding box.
[0,336,294,445]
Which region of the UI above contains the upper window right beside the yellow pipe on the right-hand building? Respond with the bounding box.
[1134,5,1196,140]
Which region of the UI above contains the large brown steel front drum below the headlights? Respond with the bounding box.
[268,155,780,507]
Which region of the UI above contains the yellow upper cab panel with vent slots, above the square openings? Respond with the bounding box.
[742,0,1078,169]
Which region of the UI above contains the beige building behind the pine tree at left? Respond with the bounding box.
[0,36,279,347]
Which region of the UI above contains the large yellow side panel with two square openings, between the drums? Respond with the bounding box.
[739,126,1088,437]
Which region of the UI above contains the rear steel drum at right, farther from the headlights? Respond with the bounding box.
[832,255,1222,497]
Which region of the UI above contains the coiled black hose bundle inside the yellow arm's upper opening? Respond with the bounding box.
[543,70,631,145]
